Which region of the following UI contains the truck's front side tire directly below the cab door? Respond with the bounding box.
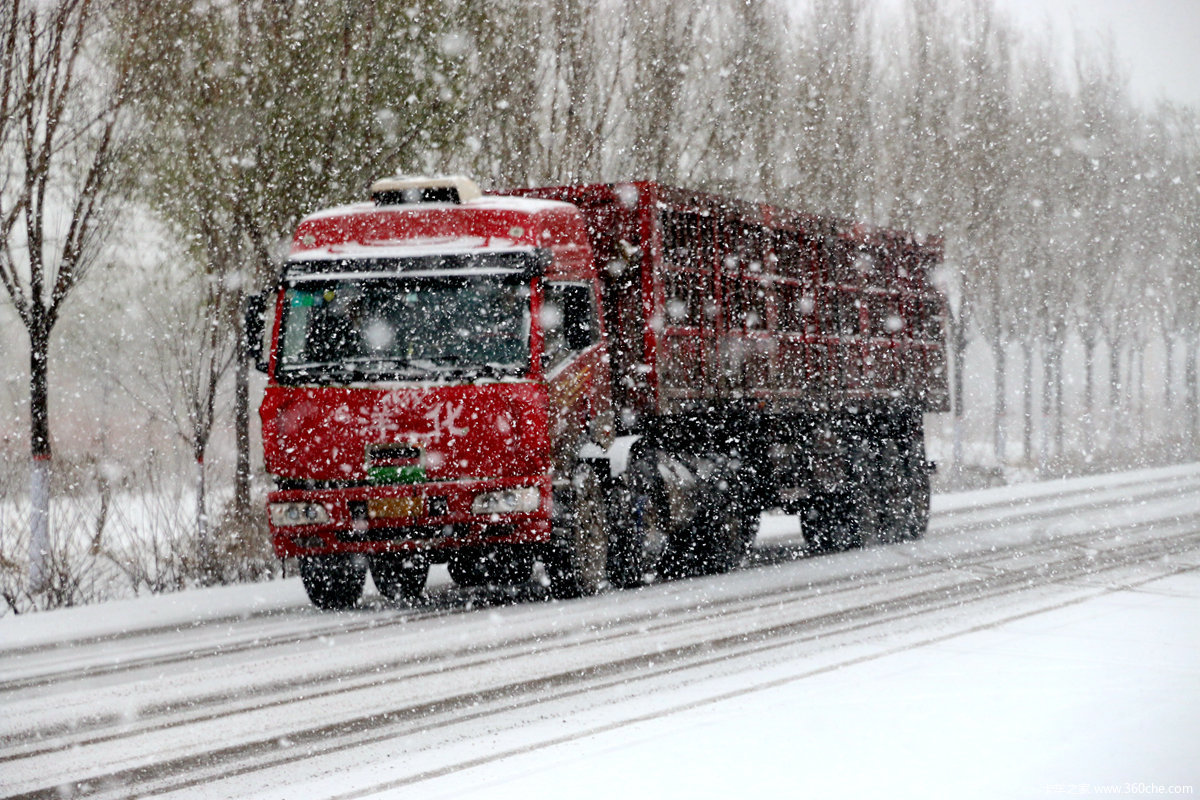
[544,464,608,599]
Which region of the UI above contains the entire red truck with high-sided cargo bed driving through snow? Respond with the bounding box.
[247,178,948,608]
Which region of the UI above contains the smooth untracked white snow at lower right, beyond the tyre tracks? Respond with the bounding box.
[415,572,1200,799]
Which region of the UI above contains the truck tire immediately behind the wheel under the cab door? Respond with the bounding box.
[608,452,671,589]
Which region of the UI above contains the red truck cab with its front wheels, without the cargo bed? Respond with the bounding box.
[252,178,612,608]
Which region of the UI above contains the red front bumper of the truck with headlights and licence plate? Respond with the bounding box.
[266,476,552,560]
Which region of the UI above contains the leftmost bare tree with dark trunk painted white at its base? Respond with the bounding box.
[0,0,132,590]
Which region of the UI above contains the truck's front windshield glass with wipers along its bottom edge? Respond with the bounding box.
[276,273,529,383]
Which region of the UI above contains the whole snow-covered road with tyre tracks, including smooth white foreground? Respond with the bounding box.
[0,465,1200,798]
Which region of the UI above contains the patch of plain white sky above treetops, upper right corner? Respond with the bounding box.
[995,0,1200,108]
